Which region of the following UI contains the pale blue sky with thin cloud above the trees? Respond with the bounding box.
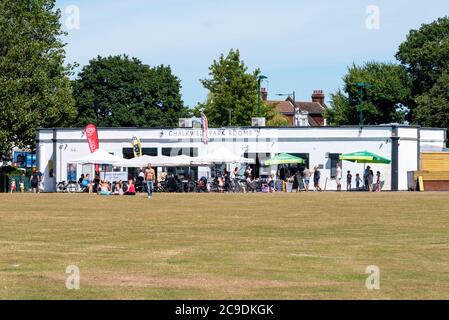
[56,0,449,107]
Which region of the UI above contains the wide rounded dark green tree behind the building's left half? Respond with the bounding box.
[73,55,189,128]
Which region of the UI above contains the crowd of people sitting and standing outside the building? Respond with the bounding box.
[52,163,382,195]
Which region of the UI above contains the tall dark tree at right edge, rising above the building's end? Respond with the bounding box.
[396,17,449,128]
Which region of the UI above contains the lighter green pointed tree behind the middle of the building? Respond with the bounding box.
[197,50,260,127]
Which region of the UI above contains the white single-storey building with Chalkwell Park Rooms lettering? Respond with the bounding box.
[36,125,446,192]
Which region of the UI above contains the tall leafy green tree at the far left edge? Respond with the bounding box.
[0,0,76,156]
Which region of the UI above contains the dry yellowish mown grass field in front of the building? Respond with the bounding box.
[0,193,449,299]
